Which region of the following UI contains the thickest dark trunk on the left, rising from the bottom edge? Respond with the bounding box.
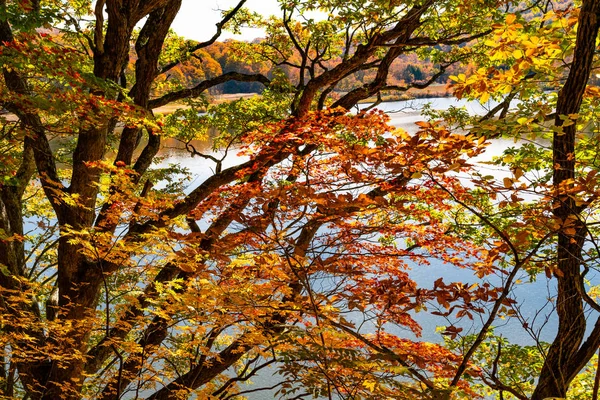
[17,0,179,400]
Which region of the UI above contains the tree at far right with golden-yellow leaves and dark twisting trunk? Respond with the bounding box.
[448,1,600,399]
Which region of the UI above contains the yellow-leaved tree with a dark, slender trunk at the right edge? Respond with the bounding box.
[454,1,600,400]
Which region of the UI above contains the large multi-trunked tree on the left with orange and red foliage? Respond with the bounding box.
[0,0,506,399]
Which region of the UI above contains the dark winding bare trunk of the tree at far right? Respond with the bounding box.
[532,0,600,400]
